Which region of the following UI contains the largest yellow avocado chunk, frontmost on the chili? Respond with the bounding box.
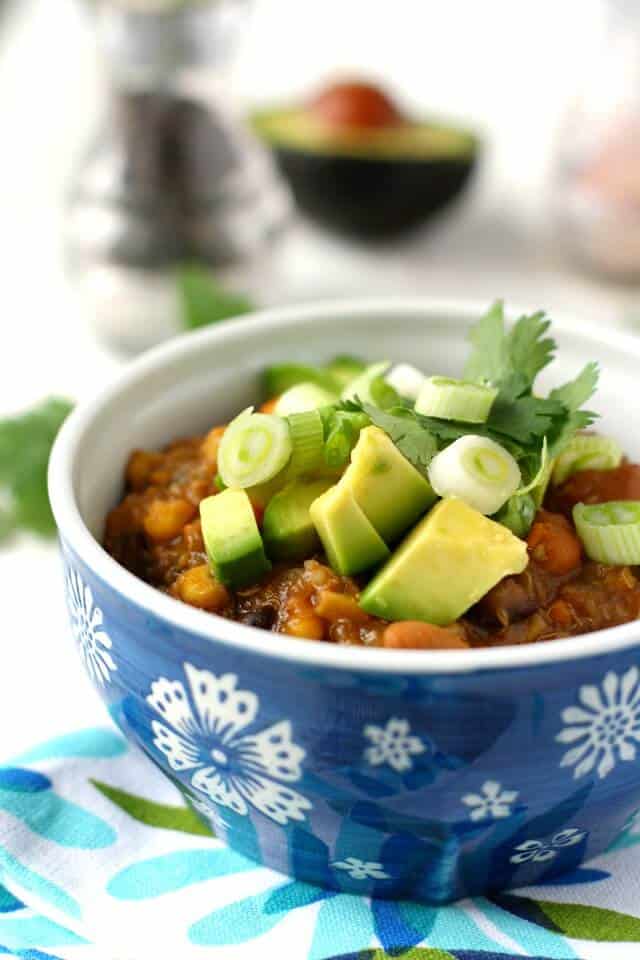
[360,497,527,626]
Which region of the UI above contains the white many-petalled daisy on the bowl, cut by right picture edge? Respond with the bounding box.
[556,667,640,780]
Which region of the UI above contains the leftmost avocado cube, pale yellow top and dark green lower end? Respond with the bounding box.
[200,489,271,589]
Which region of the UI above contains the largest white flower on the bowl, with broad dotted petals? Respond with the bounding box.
[146,663,312,826]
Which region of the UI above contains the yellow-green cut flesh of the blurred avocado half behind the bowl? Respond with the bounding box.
[252,109,476,161]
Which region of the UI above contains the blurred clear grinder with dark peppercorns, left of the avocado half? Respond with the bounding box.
[67,0,289,352]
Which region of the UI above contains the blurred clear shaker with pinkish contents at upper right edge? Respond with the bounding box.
[555,0,640,282]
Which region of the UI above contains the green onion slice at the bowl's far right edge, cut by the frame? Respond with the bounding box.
[573,500,640,566]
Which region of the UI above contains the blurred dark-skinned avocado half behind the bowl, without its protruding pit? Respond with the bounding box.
[252,109,478,240]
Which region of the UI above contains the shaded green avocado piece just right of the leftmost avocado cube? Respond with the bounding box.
[262,480,333,560]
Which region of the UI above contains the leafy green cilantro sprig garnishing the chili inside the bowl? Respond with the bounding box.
[324,302,598,483]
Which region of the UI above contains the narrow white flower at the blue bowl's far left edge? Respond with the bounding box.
[66,569,118,687]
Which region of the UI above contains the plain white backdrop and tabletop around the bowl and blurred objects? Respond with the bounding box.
[0,0,640,757]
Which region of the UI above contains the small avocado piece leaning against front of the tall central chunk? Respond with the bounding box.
[309,483,389,576]
